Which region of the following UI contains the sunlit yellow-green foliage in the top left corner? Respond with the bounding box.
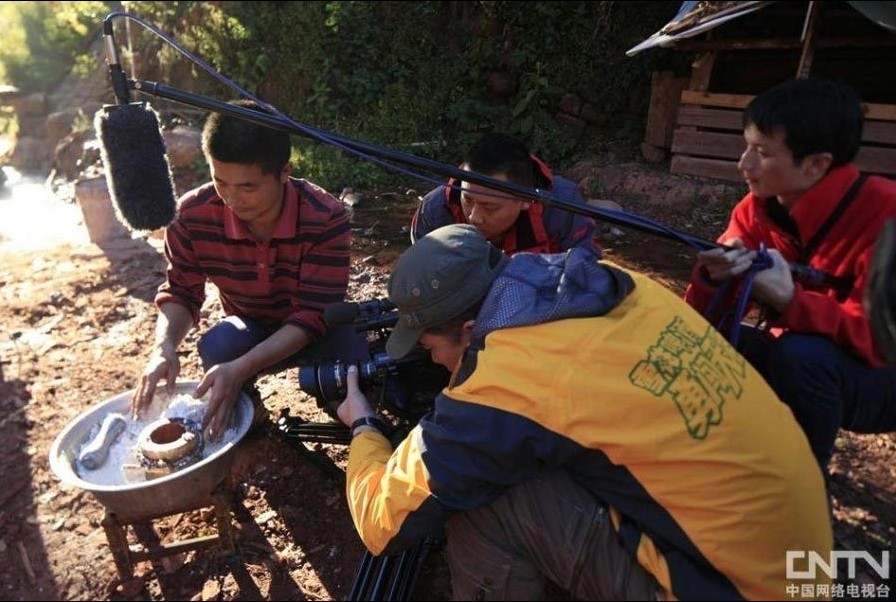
[0,2,111,92]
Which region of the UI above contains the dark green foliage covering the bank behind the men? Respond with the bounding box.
[0,1,678,189]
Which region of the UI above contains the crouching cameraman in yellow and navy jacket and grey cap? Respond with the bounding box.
[338,225,832,600]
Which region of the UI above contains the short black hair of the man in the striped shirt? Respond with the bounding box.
[202,100,292,174]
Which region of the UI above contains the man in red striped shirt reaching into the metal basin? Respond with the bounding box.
[131,101,351,439]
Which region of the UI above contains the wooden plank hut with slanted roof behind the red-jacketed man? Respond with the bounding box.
[629,1,896,181]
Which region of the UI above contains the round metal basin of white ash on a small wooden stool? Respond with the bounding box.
[50,381,254,522]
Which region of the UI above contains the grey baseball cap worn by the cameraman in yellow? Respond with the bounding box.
[386,224,508,359]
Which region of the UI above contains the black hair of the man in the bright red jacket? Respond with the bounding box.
[744,78,864,167]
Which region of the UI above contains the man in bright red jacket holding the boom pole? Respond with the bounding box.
[686,79,896,468]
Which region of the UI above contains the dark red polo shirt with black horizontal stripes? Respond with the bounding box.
[155,178,351,338]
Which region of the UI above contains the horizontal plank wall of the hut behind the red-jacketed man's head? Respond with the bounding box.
[671,90,896,182]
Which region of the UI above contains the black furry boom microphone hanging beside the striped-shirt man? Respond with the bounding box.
[94,17,177,230]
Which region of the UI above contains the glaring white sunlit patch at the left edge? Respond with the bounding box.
[0,167,89,250]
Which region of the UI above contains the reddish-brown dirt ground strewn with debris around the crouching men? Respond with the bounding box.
[0,171,896,600]
